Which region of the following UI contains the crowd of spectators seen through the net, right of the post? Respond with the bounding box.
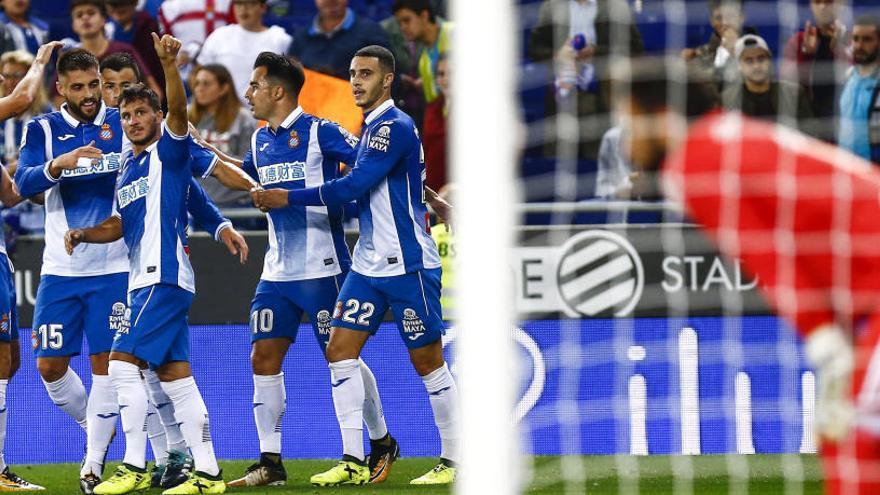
[523,0,880,199]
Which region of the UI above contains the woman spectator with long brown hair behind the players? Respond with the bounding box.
[188,61,256,206]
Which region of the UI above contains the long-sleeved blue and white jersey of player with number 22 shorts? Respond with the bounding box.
[288,100,440,277]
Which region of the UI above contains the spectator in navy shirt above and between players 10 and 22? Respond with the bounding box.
[290,0,388,79]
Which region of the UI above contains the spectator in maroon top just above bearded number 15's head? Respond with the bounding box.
[61,0,164,107]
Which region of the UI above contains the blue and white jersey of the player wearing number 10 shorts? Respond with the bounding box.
[242,107,357,282]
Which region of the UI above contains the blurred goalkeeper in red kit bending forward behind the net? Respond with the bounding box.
[615,59,880,494]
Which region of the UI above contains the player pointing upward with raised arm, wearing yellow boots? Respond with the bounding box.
[64,34,241,495]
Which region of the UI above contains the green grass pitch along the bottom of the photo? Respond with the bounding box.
[6,455,822,495]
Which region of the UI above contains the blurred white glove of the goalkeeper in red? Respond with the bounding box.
[806,325,855,442]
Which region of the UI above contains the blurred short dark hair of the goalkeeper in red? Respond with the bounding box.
[612,57,720,119]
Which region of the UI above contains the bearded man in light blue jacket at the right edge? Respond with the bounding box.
[838,15,880,164]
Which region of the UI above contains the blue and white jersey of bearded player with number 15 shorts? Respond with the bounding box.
[15,104,128,277]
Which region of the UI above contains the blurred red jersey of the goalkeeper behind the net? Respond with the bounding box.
[662,113,880,334]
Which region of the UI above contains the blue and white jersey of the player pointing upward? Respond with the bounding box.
[114,122,216,293]
